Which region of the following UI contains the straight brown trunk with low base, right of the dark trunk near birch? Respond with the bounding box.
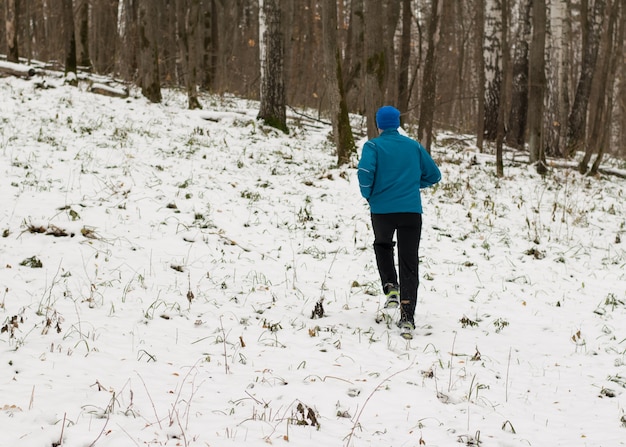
[528,0,547,174]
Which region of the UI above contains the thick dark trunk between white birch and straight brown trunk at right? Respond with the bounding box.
[506,0,532,148]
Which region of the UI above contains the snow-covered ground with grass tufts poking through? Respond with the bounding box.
[0,78,626,447]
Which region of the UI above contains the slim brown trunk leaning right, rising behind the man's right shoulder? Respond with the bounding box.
[417,0,445,152]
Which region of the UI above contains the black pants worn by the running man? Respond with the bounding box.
[372,213,422,322]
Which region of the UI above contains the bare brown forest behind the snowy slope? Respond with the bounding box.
[0,0,626,175]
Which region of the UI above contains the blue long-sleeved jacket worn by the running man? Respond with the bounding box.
[357,129,441,214]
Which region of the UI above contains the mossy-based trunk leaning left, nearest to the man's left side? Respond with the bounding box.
[322,0,356,166]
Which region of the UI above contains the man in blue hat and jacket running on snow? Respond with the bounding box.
[358,106,441,338]
